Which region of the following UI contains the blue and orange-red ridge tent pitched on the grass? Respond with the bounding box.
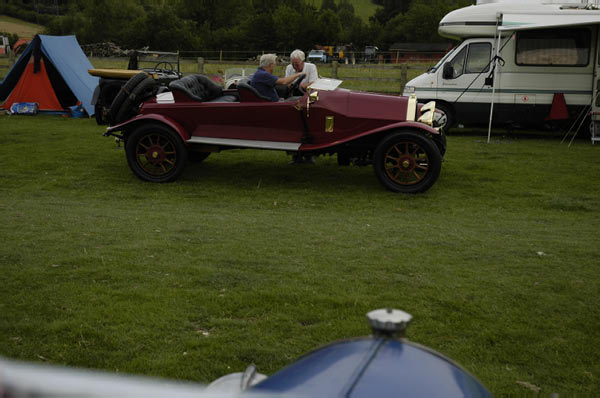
[0,35,99,116]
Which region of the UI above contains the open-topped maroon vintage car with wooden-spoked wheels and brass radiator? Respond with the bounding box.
[105,74,446,193]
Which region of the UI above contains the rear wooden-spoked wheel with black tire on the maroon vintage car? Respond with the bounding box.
[125,123,187,182]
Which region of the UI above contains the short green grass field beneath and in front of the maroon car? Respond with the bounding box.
[0,116,600,397]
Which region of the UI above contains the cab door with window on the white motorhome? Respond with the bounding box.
[438,39,493,123]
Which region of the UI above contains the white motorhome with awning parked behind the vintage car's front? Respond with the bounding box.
[404,0,600,140]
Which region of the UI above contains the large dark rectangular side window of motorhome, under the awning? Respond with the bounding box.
[515,28,591,66]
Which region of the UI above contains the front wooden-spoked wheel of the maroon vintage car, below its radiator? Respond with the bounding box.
[373,131,442,193]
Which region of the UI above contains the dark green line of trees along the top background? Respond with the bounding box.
[0,0,472,51]
